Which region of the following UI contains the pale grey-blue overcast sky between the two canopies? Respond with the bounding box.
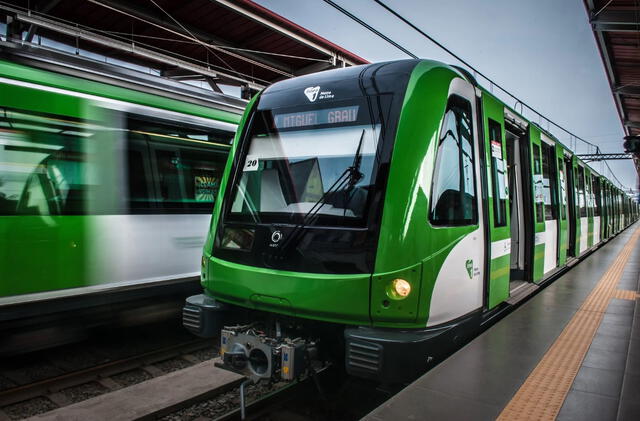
[254,0,636,187]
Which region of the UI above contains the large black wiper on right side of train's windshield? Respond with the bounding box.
[280,129,366,255]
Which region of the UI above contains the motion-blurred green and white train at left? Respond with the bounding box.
[0,44,246,353]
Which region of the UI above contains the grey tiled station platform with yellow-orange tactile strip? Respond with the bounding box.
[364,223,640,421]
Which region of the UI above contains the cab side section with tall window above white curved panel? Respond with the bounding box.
[423,78,488,326]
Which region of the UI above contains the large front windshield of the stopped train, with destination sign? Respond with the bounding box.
[229,101,381,226]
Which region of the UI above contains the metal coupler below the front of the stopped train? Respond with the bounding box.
[219,324,322,383]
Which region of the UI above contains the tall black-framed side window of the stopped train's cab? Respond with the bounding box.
[429,95,478,226]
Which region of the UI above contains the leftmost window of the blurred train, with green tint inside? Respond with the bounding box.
[0,108,92,215]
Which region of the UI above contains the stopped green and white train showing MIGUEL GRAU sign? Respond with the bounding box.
[183,60,638,382]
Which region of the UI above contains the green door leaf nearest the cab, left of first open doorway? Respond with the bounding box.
[482,92,511,309]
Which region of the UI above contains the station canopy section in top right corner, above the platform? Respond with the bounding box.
[585,0,640,174]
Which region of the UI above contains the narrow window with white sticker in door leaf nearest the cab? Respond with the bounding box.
[489,119,507,227]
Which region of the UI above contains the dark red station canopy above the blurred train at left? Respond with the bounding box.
[0,0,367,97]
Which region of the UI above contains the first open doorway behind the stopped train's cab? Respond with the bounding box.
[505,113,528,296]
